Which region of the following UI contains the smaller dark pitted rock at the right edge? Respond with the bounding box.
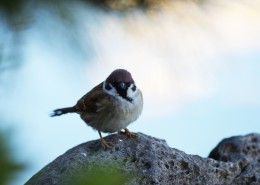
[209,134,260,185]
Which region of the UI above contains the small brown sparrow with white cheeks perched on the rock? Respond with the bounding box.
[50,69,143,148]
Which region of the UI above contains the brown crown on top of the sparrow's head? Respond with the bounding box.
[106,69,134,83]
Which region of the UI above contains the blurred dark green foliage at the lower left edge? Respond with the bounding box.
[0,131,25,185]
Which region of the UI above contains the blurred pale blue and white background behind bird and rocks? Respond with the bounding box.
[0,0,260,184]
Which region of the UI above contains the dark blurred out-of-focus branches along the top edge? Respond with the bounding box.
[0,0,207,30]
